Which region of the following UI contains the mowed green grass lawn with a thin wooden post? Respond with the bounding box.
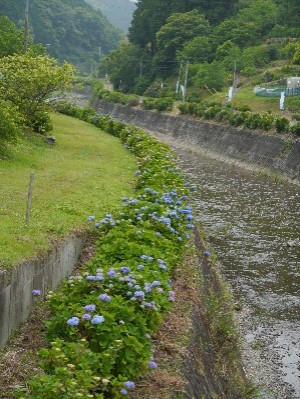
[0,114,136,272]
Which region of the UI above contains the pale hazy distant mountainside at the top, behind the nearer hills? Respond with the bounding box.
[85,0,136,33]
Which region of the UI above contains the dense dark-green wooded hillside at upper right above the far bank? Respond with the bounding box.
[103,0,300,94]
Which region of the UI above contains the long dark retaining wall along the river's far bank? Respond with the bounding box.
[92,100,300,180]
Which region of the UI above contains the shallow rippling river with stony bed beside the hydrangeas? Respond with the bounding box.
[169,143,300,399]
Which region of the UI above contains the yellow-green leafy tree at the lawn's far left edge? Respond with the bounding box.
[0,51,74,133]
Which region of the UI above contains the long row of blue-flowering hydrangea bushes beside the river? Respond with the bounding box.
[17,104,196,399]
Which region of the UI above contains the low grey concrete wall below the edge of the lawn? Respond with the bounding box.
[0,237,85,348]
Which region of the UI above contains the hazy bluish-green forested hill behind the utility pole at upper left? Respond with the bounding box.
[0,0,122,70]
